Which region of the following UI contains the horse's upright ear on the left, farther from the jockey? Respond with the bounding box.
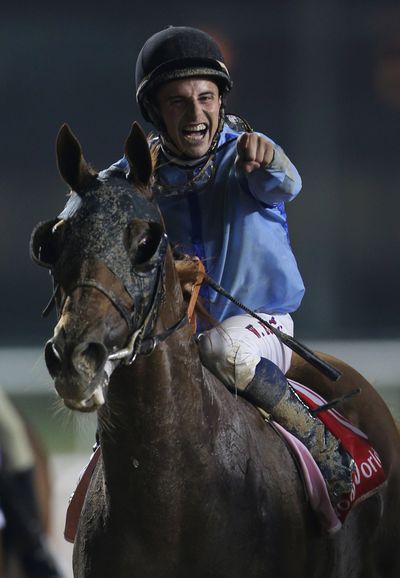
[56,124,97,193]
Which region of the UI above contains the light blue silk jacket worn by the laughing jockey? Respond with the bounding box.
[64,124,304,321]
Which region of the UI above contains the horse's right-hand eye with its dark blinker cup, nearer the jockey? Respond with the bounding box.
[124,219,162,267]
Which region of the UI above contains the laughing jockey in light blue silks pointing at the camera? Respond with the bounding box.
[60,26,352,502]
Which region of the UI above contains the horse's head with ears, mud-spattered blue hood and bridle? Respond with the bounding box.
[31,124,167,411]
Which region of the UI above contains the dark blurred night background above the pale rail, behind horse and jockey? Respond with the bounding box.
[0,0,400,345]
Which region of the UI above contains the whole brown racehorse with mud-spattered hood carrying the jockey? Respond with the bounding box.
[31,123,400,578]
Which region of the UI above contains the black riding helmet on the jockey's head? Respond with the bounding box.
[136,26,232,124]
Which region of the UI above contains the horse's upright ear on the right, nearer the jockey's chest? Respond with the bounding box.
[125,122,153,187]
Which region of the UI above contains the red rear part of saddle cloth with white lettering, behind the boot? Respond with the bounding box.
[290,381,385,522]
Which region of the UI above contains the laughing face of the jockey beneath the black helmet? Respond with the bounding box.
[157,78,221,159]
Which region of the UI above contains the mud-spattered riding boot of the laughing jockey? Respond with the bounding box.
[242,358,354,505]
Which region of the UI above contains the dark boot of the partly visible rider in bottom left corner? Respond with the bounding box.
[0,469,62,578]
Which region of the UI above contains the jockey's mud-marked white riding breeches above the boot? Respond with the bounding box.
[198,313,293,390]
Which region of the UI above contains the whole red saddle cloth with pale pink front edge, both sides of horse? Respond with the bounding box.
[64,380,385,542]
